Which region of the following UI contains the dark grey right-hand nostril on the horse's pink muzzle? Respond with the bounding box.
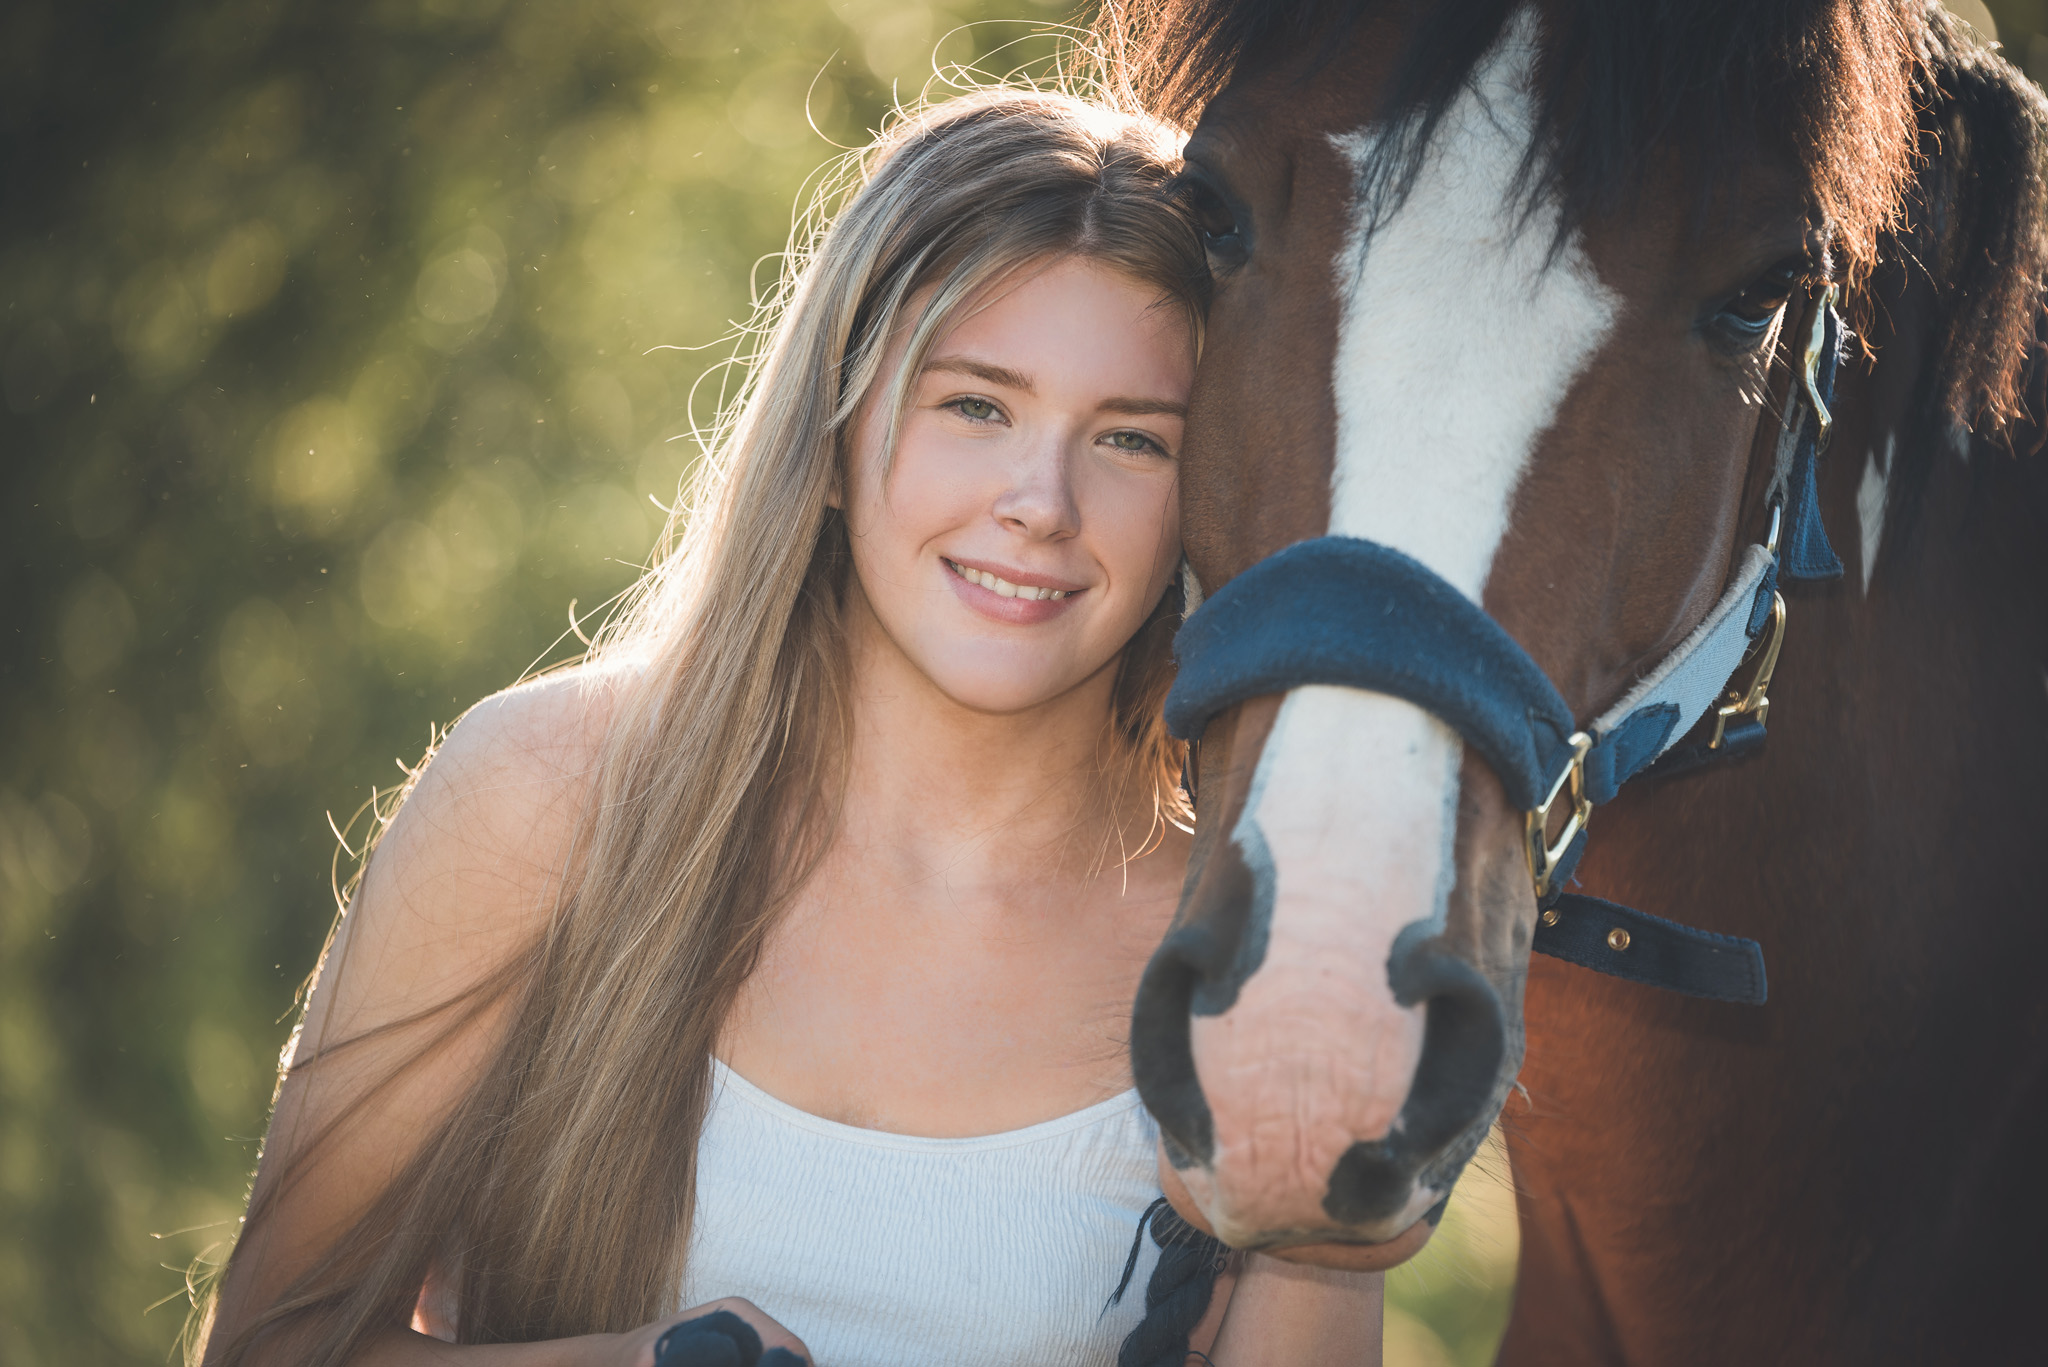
[1323,935,1507,1226]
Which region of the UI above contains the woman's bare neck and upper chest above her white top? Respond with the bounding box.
[719,594,1188,1135]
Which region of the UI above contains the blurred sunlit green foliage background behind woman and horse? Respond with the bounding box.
[0,0,2048,1367]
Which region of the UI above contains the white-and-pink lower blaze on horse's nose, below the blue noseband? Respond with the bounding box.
[1184,685,1458,1242]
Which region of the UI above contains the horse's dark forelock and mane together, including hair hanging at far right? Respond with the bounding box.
[1098,0,2048,430]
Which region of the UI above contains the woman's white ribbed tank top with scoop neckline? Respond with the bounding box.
[680,1060,1159,1367]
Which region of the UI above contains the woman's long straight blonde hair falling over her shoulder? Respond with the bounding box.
[201,90,1208,1367]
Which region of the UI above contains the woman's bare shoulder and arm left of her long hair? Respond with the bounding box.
[219,670,638,1332]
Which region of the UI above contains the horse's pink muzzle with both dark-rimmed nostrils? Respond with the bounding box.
[1130,827,1507,1260]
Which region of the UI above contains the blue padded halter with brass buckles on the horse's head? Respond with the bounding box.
[1165,285,1845,1004]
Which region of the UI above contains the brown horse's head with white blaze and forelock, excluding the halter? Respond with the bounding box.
[1124,0,1946,1267]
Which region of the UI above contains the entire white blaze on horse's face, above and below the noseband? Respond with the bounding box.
[1190,10,1618,1238]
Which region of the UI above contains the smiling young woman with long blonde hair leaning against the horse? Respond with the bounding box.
[201,92,1378,1367]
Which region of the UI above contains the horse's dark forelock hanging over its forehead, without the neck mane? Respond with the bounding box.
[1098,0,1948,266]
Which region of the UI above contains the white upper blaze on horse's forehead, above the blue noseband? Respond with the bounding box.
[1329,10,1620,603]
